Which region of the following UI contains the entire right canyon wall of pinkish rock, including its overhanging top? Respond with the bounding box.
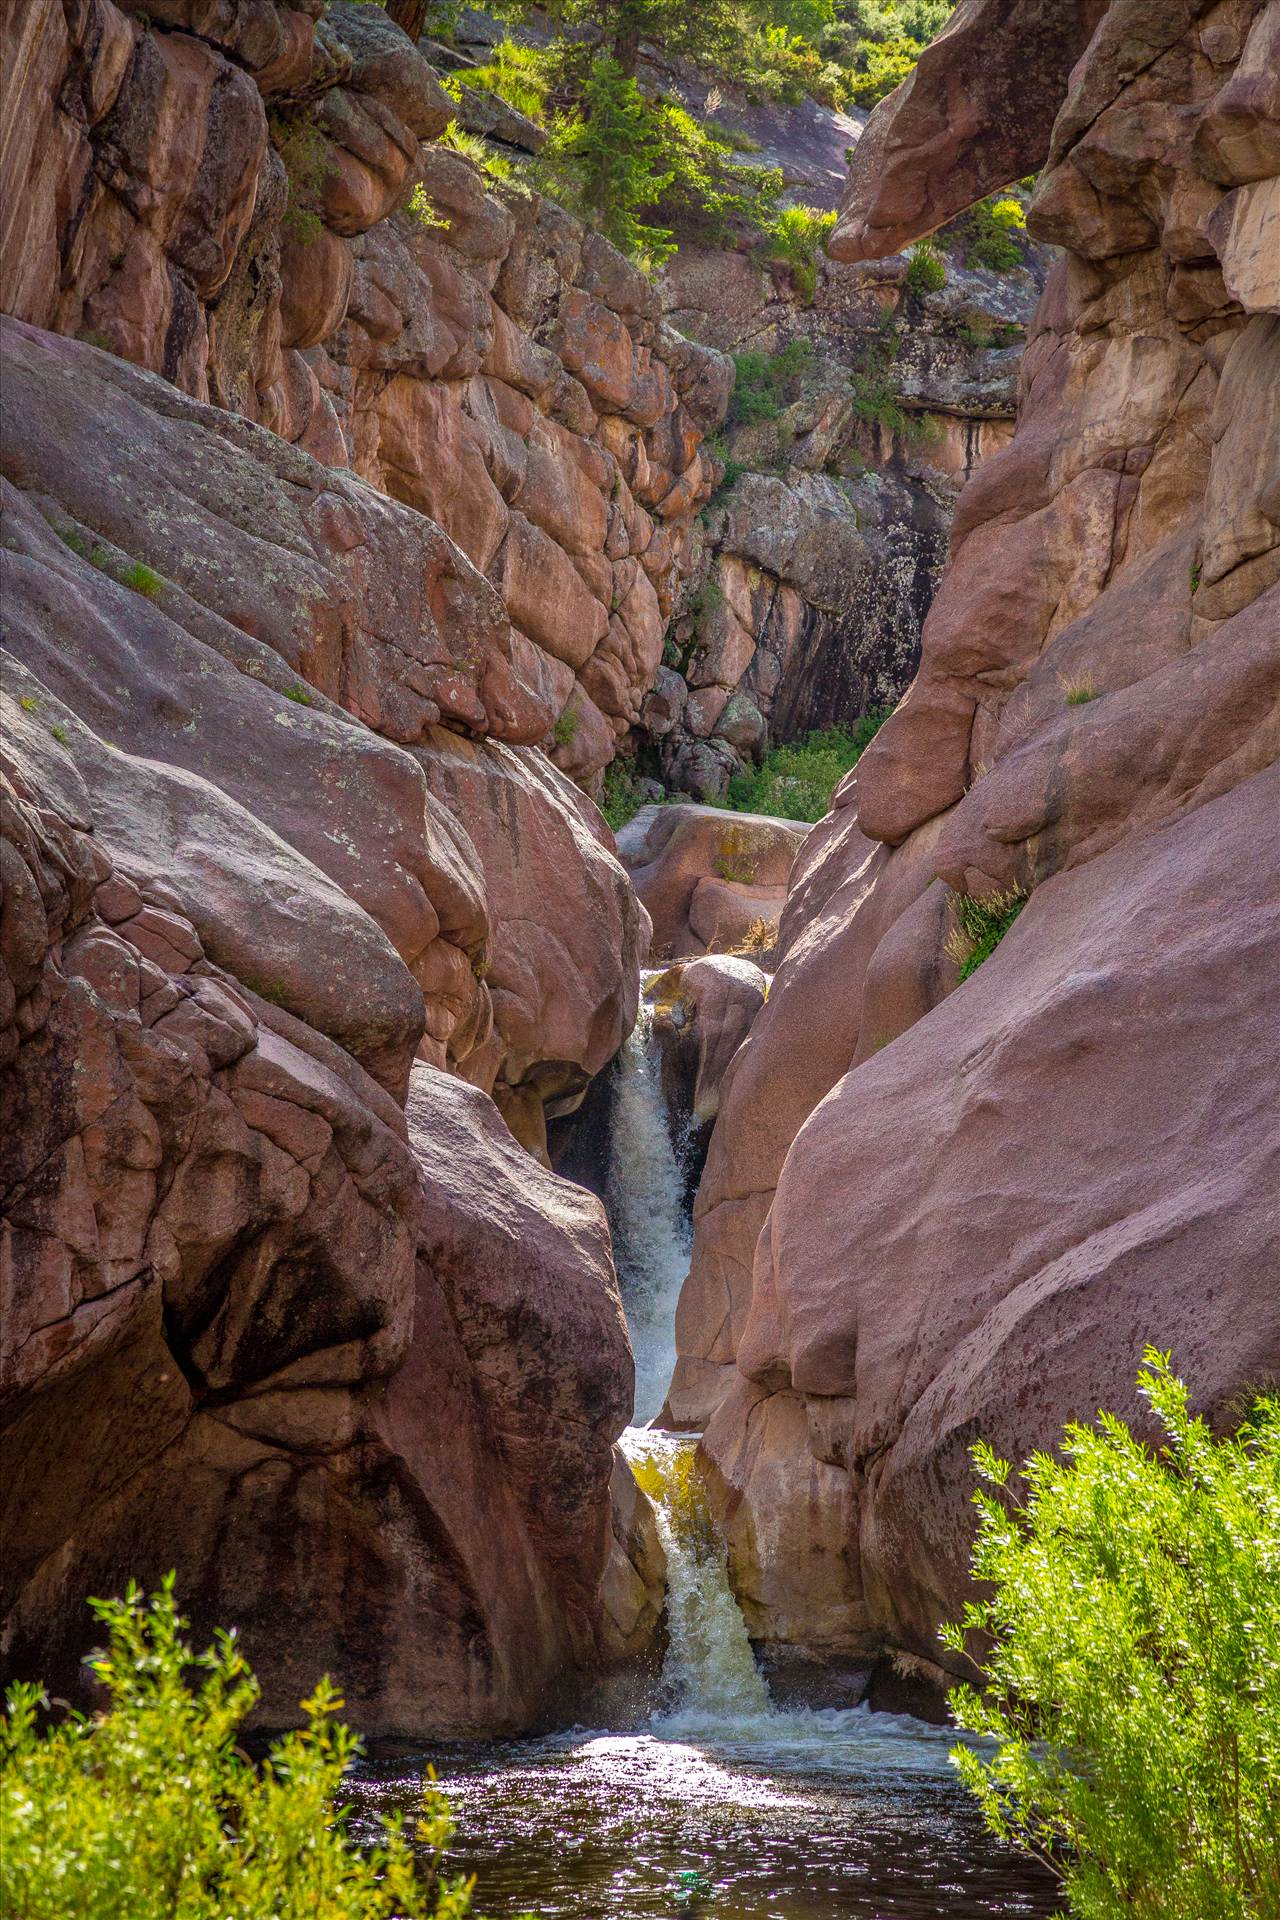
[672,0,1280,1661]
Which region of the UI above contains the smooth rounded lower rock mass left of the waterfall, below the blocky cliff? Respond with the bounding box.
[0,321,652,1734]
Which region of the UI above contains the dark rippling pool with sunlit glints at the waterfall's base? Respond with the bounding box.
[353,1711,1059,1920]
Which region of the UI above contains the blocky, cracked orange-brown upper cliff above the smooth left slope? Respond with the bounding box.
[0,0,731,780]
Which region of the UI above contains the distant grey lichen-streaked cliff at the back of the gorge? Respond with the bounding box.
[652,234,1046,799]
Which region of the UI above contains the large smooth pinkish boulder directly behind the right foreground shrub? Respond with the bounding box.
[721,764,1280,1659]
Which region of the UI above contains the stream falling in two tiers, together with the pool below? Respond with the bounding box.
[351,1004,1059,1920]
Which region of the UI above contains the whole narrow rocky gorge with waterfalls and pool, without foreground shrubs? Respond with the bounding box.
[0,0,1280,1920]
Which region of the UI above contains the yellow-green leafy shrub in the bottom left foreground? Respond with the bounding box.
[0,1578,470,1920]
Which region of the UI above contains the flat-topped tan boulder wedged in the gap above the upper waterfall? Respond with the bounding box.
[618,803,806,962]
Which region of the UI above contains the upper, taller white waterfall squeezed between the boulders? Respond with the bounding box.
[606,975,693,1425]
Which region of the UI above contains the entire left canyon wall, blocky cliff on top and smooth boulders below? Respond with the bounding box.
[0,0,710,1732]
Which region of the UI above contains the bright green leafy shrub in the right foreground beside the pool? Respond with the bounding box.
[942,1348,1280,1920]
